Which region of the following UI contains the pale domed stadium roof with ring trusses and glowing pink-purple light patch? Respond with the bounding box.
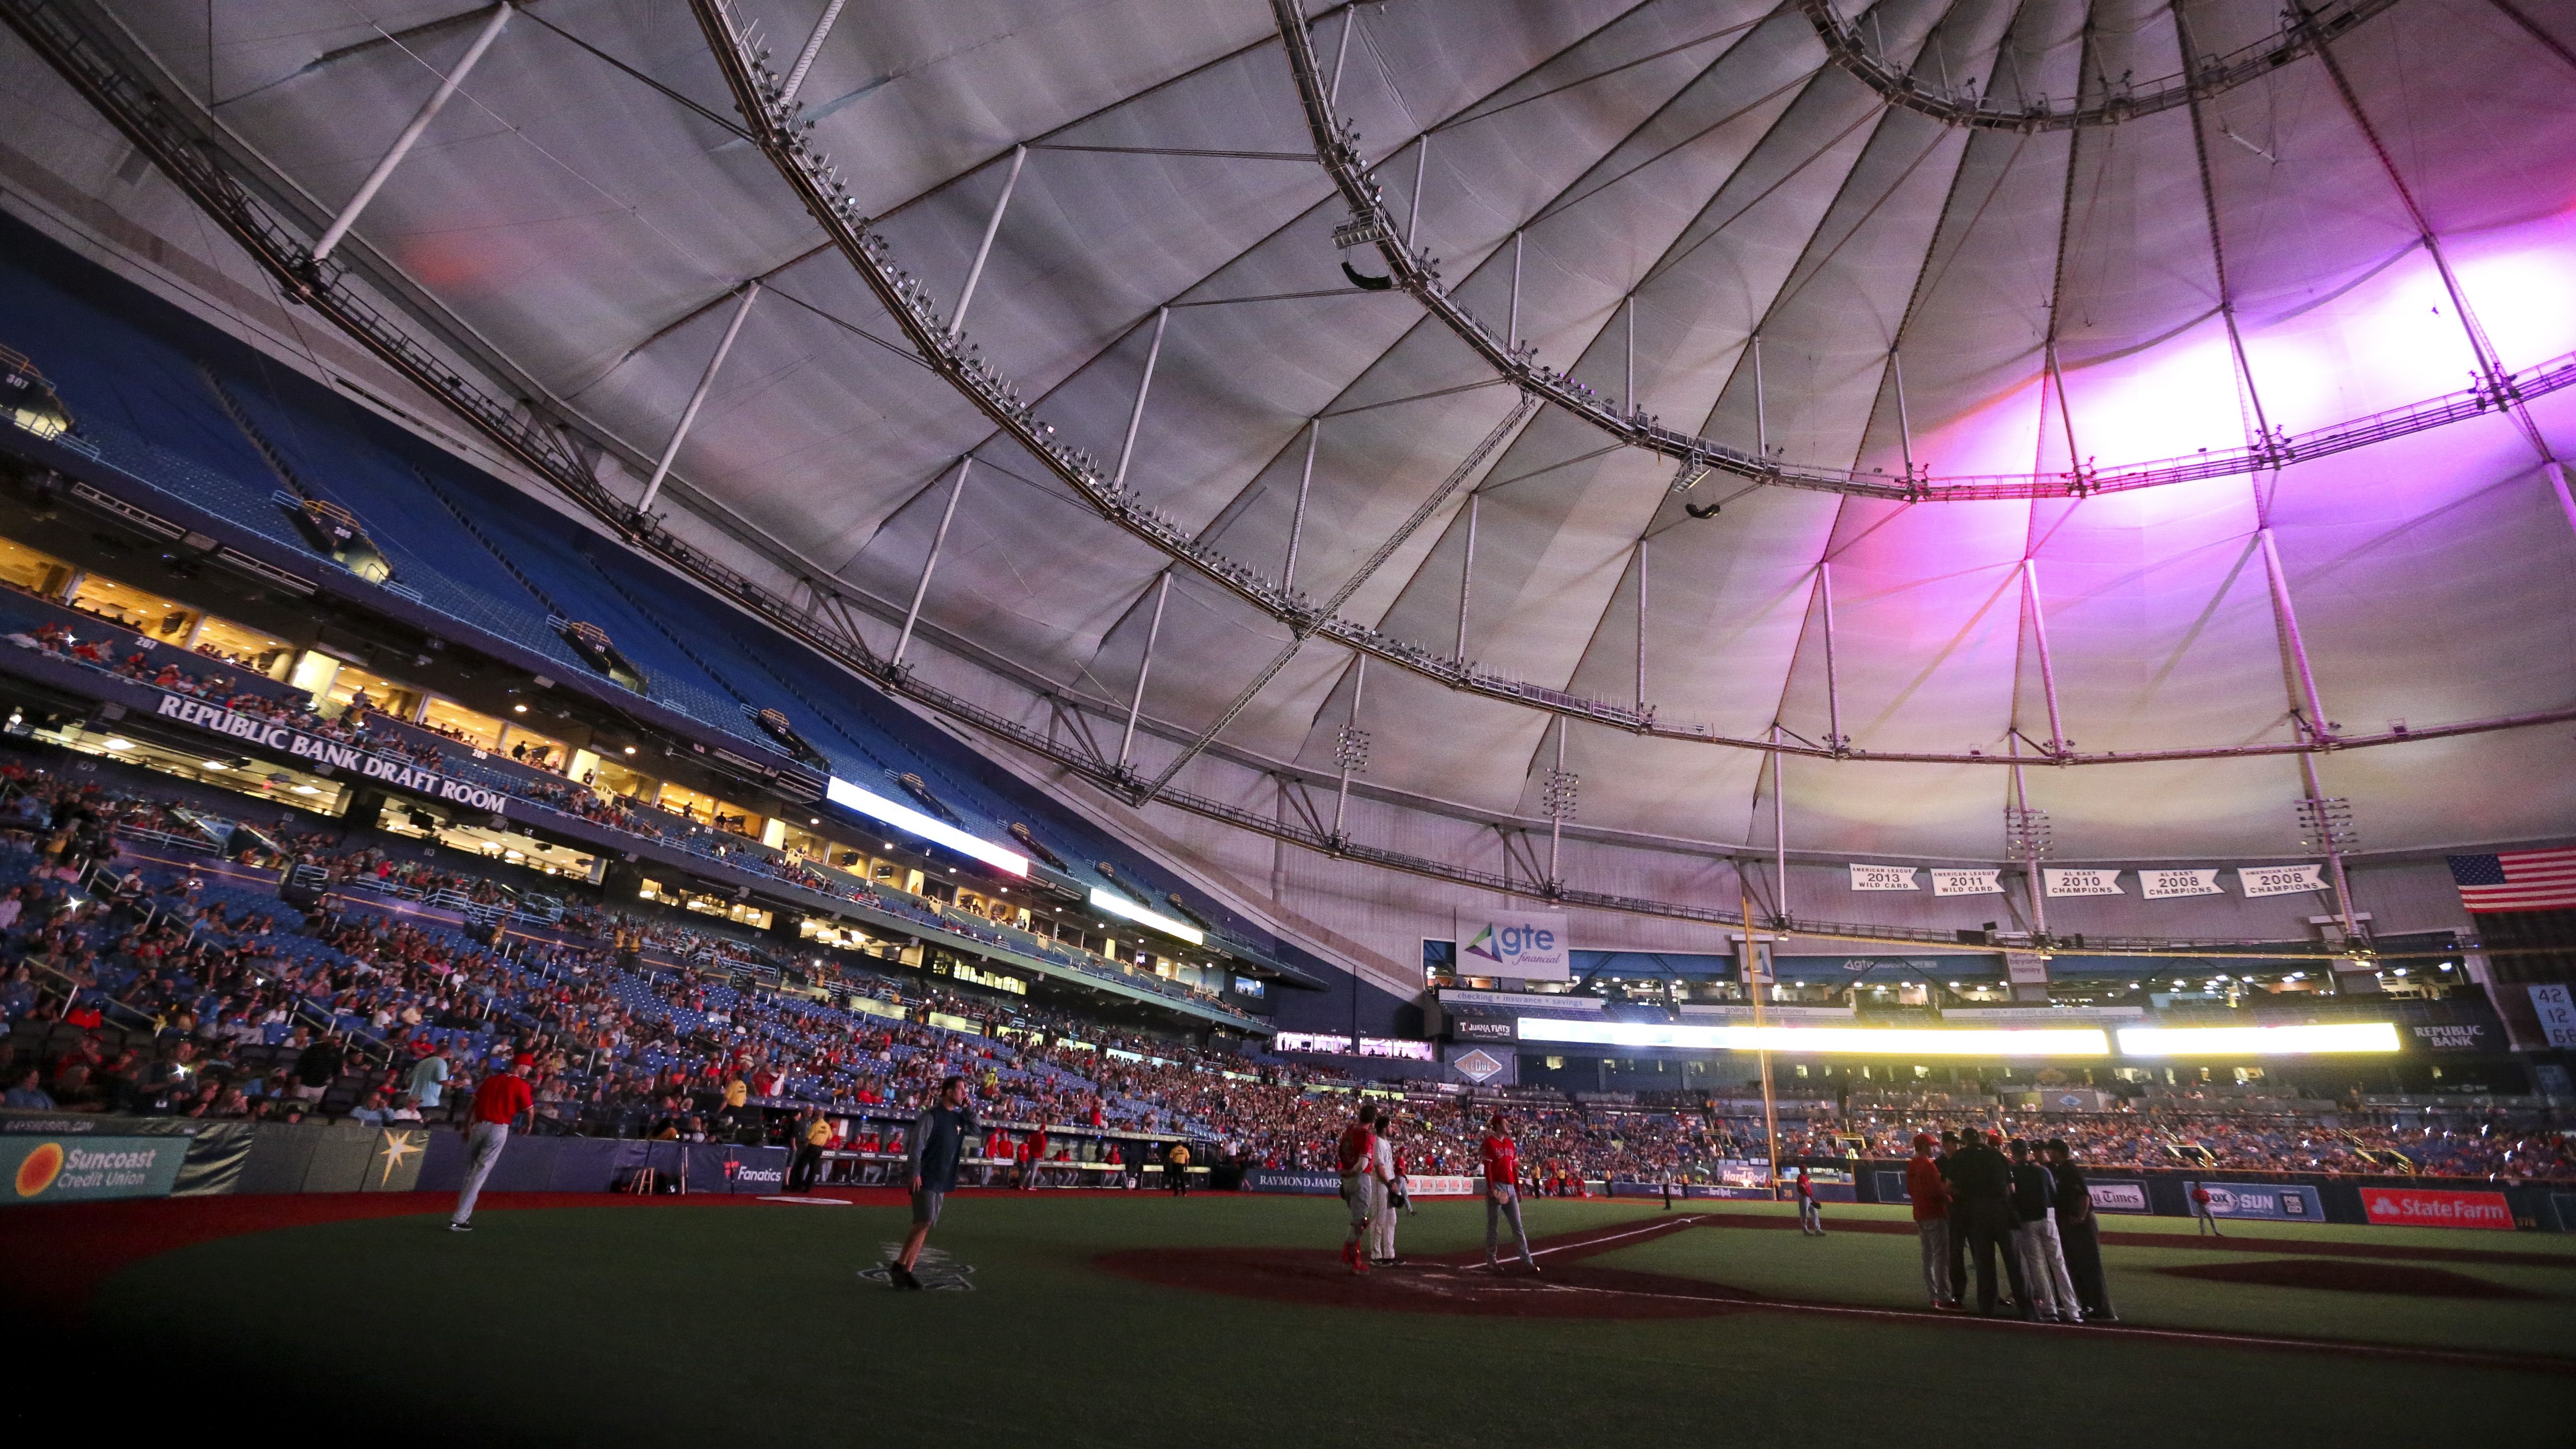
[13,0,2576,859]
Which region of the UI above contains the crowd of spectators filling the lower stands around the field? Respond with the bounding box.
[0,763,2576,1191]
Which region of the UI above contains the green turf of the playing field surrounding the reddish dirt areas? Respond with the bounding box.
[5,1194,2576,1449]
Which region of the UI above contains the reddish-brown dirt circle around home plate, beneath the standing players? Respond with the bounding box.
[1097,1248,1754,1317]
